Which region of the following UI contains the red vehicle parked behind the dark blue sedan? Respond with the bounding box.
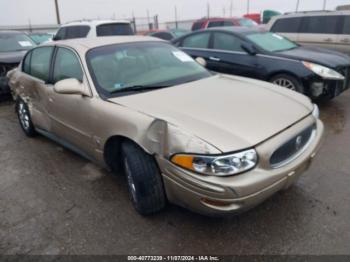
[192,17,258,31]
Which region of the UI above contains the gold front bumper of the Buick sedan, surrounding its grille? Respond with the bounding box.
[157,116,324,215]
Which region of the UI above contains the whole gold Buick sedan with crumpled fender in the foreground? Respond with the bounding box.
[9,36,324,215]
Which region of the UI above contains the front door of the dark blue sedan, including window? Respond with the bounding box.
[207,32,259,78]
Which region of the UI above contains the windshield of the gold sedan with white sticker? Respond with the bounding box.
[87,42,211,97]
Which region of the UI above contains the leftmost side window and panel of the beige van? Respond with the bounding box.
[270,17,301,41]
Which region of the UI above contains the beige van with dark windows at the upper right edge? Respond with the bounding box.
[268,11,350,54]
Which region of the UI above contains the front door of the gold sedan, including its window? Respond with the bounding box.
[48,47,93,155]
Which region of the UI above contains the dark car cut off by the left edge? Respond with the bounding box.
[0,31,35,100]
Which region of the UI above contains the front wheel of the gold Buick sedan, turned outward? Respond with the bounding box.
[122,142,166,215]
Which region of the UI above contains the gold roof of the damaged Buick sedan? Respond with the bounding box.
[41,36,164,51]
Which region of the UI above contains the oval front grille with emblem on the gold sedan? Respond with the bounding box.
[270,125,316,168]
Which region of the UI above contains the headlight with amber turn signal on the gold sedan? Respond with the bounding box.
[171,149,258,176]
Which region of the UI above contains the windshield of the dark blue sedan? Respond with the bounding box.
[247,32,298,52]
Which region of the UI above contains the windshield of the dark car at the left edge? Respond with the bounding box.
[0,33,35,52]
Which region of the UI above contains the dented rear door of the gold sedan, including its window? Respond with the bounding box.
[18,47,54,131]
